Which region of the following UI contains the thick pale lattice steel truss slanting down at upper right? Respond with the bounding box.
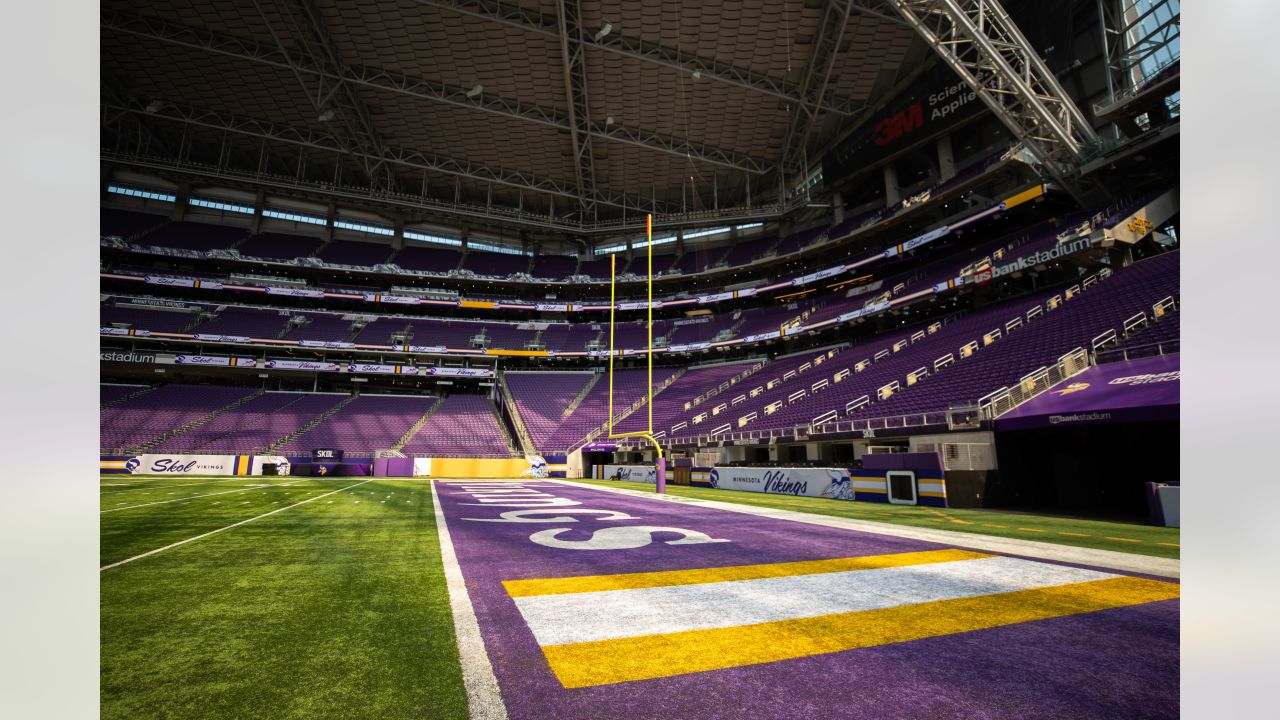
[884,0,1098,179]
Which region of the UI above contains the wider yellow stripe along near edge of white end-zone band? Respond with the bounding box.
[543,578,1179,688]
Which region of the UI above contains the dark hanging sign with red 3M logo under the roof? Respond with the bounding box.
[822,63,986,186]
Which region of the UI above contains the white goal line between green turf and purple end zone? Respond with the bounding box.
[431,483,507,720]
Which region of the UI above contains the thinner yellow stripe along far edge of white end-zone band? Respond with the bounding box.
[502,550,991,597]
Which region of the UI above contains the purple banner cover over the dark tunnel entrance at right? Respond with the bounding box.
[996,355,1181,430]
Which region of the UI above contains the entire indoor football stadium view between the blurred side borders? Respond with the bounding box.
[99,0,1181,720]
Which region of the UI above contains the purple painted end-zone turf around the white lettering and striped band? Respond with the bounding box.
[436,480,1179,720]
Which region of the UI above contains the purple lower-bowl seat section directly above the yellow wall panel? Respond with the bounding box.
[402,395,512,457]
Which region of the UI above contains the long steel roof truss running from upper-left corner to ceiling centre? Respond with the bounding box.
[101,8,772,174]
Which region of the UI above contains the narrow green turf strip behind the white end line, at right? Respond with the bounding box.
[573,480,1180,557]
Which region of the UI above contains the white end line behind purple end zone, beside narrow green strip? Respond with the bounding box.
[550,479,1181,578]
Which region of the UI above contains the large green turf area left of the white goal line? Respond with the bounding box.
[100,475,467,719]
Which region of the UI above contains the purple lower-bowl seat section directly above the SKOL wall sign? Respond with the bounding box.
[280,395,436,455]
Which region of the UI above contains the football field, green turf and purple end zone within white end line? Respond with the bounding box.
[100,475,1179,720]
